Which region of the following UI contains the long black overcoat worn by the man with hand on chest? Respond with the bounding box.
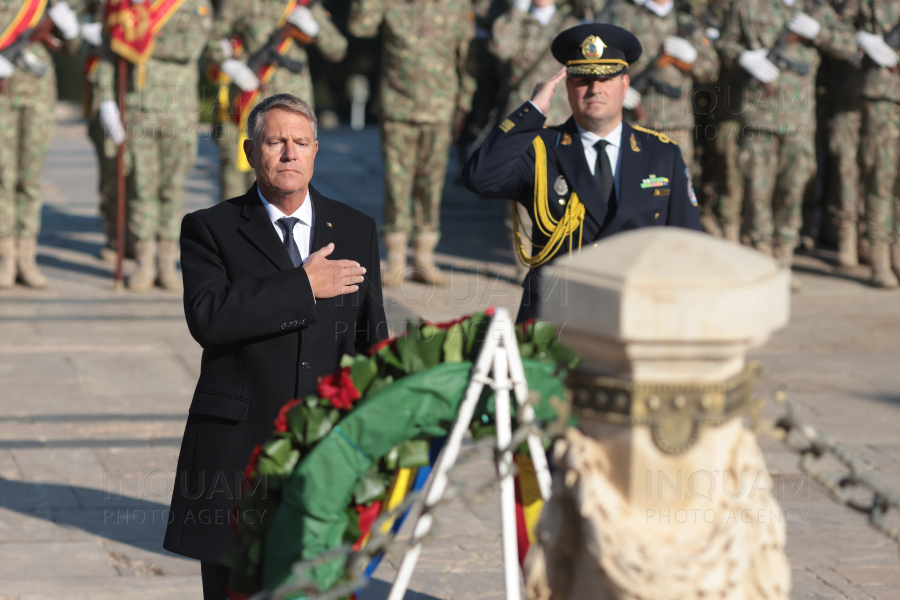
[163,185,387,564]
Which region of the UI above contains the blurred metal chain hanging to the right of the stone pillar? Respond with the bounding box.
[751,392,900,544]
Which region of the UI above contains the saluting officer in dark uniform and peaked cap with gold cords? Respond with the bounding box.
[463,23,700,322]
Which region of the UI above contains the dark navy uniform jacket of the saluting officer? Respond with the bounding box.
[463,102,700,321]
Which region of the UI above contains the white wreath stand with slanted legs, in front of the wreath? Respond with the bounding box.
[388,308,551,600]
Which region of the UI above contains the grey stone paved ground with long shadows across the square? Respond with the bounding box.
[0,105,900,600]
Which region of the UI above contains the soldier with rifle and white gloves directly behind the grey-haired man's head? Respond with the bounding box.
[208,0,347,201]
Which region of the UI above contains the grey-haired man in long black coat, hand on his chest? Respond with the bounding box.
[164,94,388,600]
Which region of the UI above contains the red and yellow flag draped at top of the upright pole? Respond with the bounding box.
[105,0,185,65]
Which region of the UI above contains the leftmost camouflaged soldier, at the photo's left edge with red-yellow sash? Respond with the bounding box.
[0,0,80,288]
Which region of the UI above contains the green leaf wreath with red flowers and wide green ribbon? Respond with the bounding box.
[226,309,579,600]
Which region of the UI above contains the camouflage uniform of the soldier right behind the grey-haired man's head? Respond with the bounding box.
[208,0,347,200]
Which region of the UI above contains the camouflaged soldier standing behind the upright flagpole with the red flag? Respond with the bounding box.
[99,0,213,292]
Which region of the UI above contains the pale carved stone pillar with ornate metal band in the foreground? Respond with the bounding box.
[526,227,790,600]
